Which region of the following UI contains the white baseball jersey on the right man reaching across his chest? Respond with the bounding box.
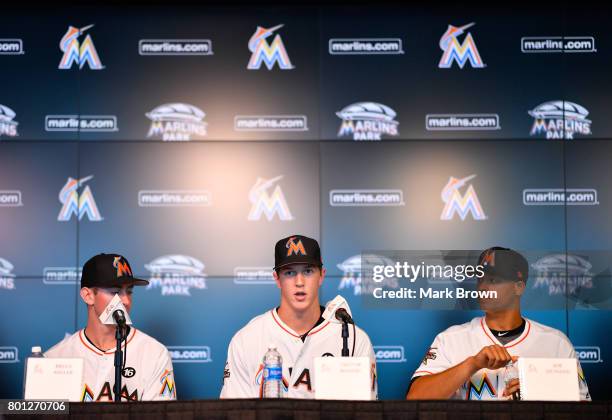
[412,317,591,400]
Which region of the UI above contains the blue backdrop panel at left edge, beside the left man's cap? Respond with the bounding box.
[0,142,78,277]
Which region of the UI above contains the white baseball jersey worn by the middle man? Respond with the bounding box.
[221,309,378,399]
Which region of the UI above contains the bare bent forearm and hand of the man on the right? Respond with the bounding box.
[406,344,517,400]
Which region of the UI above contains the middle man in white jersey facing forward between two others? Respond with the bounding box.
[221,235,377,399]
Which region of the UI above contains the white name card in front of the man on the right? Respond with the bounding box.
[518,357,580,401]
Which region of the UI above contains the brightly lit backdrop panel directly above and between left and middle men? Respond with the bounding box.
[79,142,319,277]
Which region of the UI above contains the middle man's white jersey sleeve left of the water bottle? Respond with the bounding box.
[220,335,259,398]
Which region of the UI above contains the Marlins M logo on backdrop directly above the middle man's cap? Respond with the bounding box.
[248,175,293,221]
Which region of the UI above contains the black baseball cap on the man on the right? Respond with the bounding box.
[478,246,529,282]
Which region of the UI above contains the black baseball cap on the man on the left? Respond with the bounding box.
[81,254,149,287]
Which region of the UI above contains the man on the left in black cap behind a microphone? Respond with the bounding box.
[45,254,176,402]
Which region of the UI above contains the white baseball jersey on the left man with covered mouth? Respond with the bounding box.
[45,327,176,402]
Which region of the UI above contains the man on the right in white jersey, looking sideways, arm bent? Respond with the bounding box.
[406,247,591,400]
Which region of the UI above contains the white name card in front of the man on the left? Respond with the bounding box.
[24,357,83,401]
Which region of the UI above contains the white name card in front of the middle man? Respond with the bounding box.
[314,357,372,400]
